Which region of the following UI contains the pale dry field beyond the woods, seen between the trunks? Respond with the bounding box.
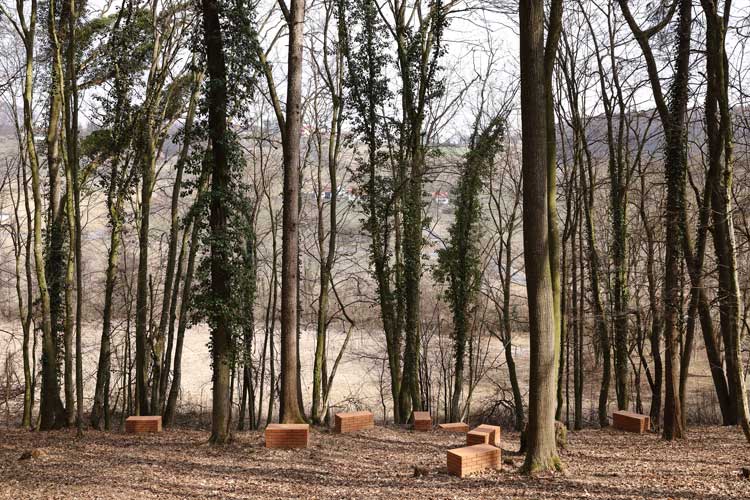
[0,323,718,425]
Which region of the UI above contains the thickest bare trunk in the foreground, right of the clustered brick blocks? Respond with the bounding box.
[519,0,561,472]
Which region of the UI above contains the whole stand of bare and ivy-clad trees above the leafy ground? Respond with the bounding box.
[0,0,750,471]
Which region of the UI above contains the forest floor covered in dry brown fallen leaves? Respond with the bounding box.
[0,427,750,500]
